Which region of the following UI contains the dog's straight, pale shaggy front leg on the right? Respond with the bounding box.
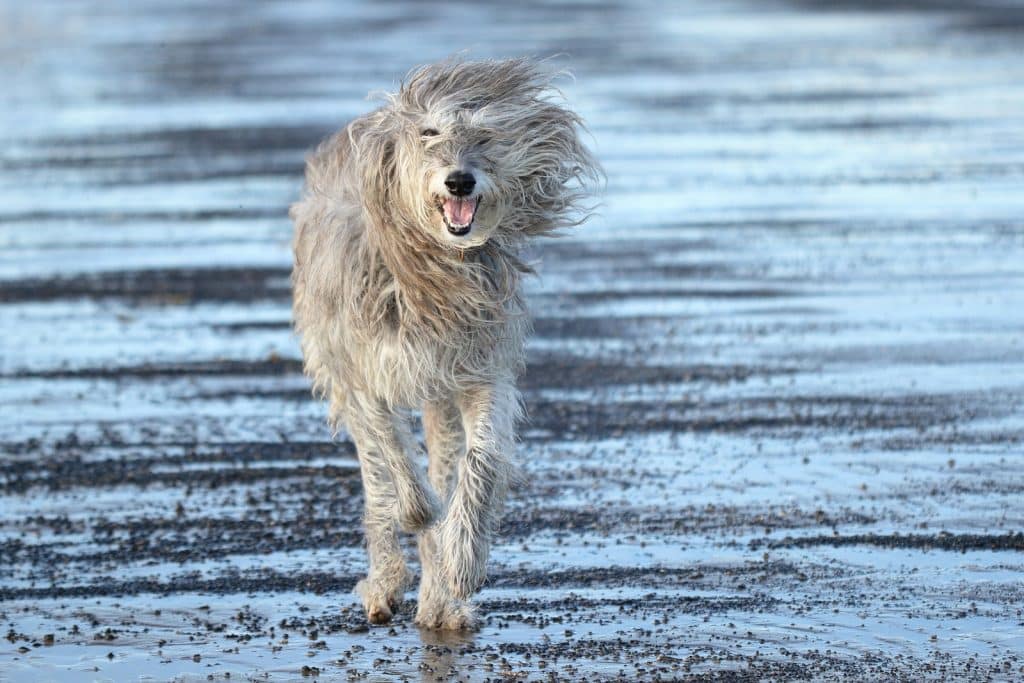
[437,381,518,600]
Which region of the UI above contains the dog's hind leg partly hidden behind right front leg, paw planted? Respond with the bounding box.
[416,400,476,630]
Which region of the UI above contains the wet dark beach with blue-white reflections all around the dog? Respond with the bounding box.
[0,0,1024,681]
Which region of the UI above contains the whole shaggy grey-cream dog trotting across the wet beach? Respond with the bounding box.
[291,59,600,629]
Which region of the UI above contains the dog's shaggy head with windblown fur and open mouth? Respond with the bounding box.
[350,59,600,249]
